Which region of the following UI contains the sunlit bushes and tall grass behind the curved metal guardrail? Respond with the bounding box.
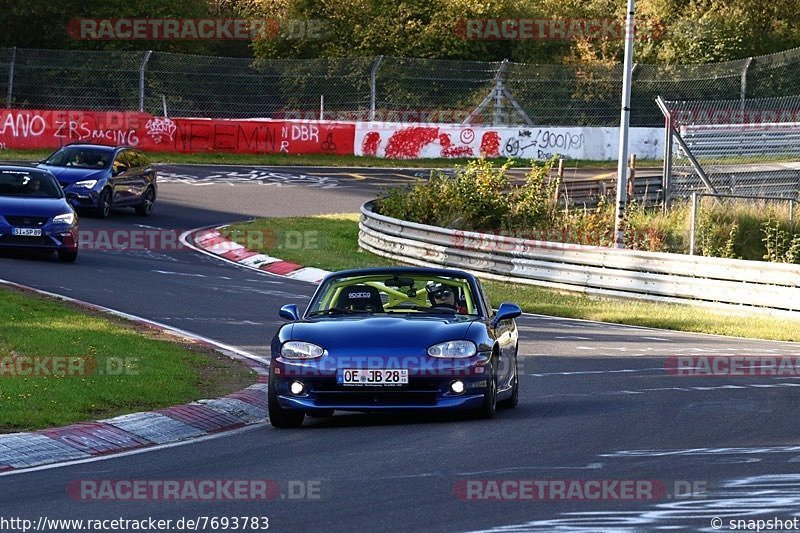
[377,160,800,263]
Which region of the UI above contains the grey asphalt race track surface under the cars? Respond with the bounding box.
[0,167,800,531]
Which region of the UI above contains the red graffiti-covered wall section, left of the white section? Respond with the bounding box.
[0,109,355,155]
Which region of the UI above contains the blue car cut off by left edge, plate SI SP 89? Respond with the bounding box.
[0,166,78,263]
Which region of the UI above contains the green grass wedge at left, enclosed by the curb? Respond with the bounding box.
[0,288,255,432]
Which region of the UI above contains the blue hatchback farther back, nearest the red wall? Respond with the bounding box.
[38,144,158,218]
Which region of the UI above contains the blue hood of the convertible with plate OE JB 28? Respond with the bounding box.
[291,315,475,355]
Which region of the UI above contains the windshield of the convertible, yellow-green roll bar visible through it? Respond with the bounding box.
[307,271,480,316]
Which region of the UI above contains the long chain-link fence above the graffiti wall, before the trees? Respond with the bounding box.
[0,48,800,126]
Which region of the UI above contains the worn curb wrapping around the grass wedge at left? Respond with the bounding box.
[0,280,269,473]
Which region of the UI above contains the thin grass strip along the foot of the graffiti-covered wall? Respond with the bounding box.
[0,150,661,169]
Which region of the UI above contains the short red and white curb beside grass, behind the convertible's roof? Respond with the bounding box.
[180,226,330,283]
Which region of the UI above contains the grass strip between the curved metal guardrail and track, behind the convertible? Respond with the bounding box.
[227,214,800,341]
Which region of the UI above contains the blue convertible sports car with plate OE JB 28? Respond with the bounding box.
[268,267,521,428]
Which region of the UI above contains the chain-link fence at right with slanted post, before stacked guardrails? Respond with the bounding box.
[661,96,800,198]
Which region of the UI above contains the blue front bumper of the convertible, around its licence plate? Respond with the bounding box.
[270,357,492,411]
